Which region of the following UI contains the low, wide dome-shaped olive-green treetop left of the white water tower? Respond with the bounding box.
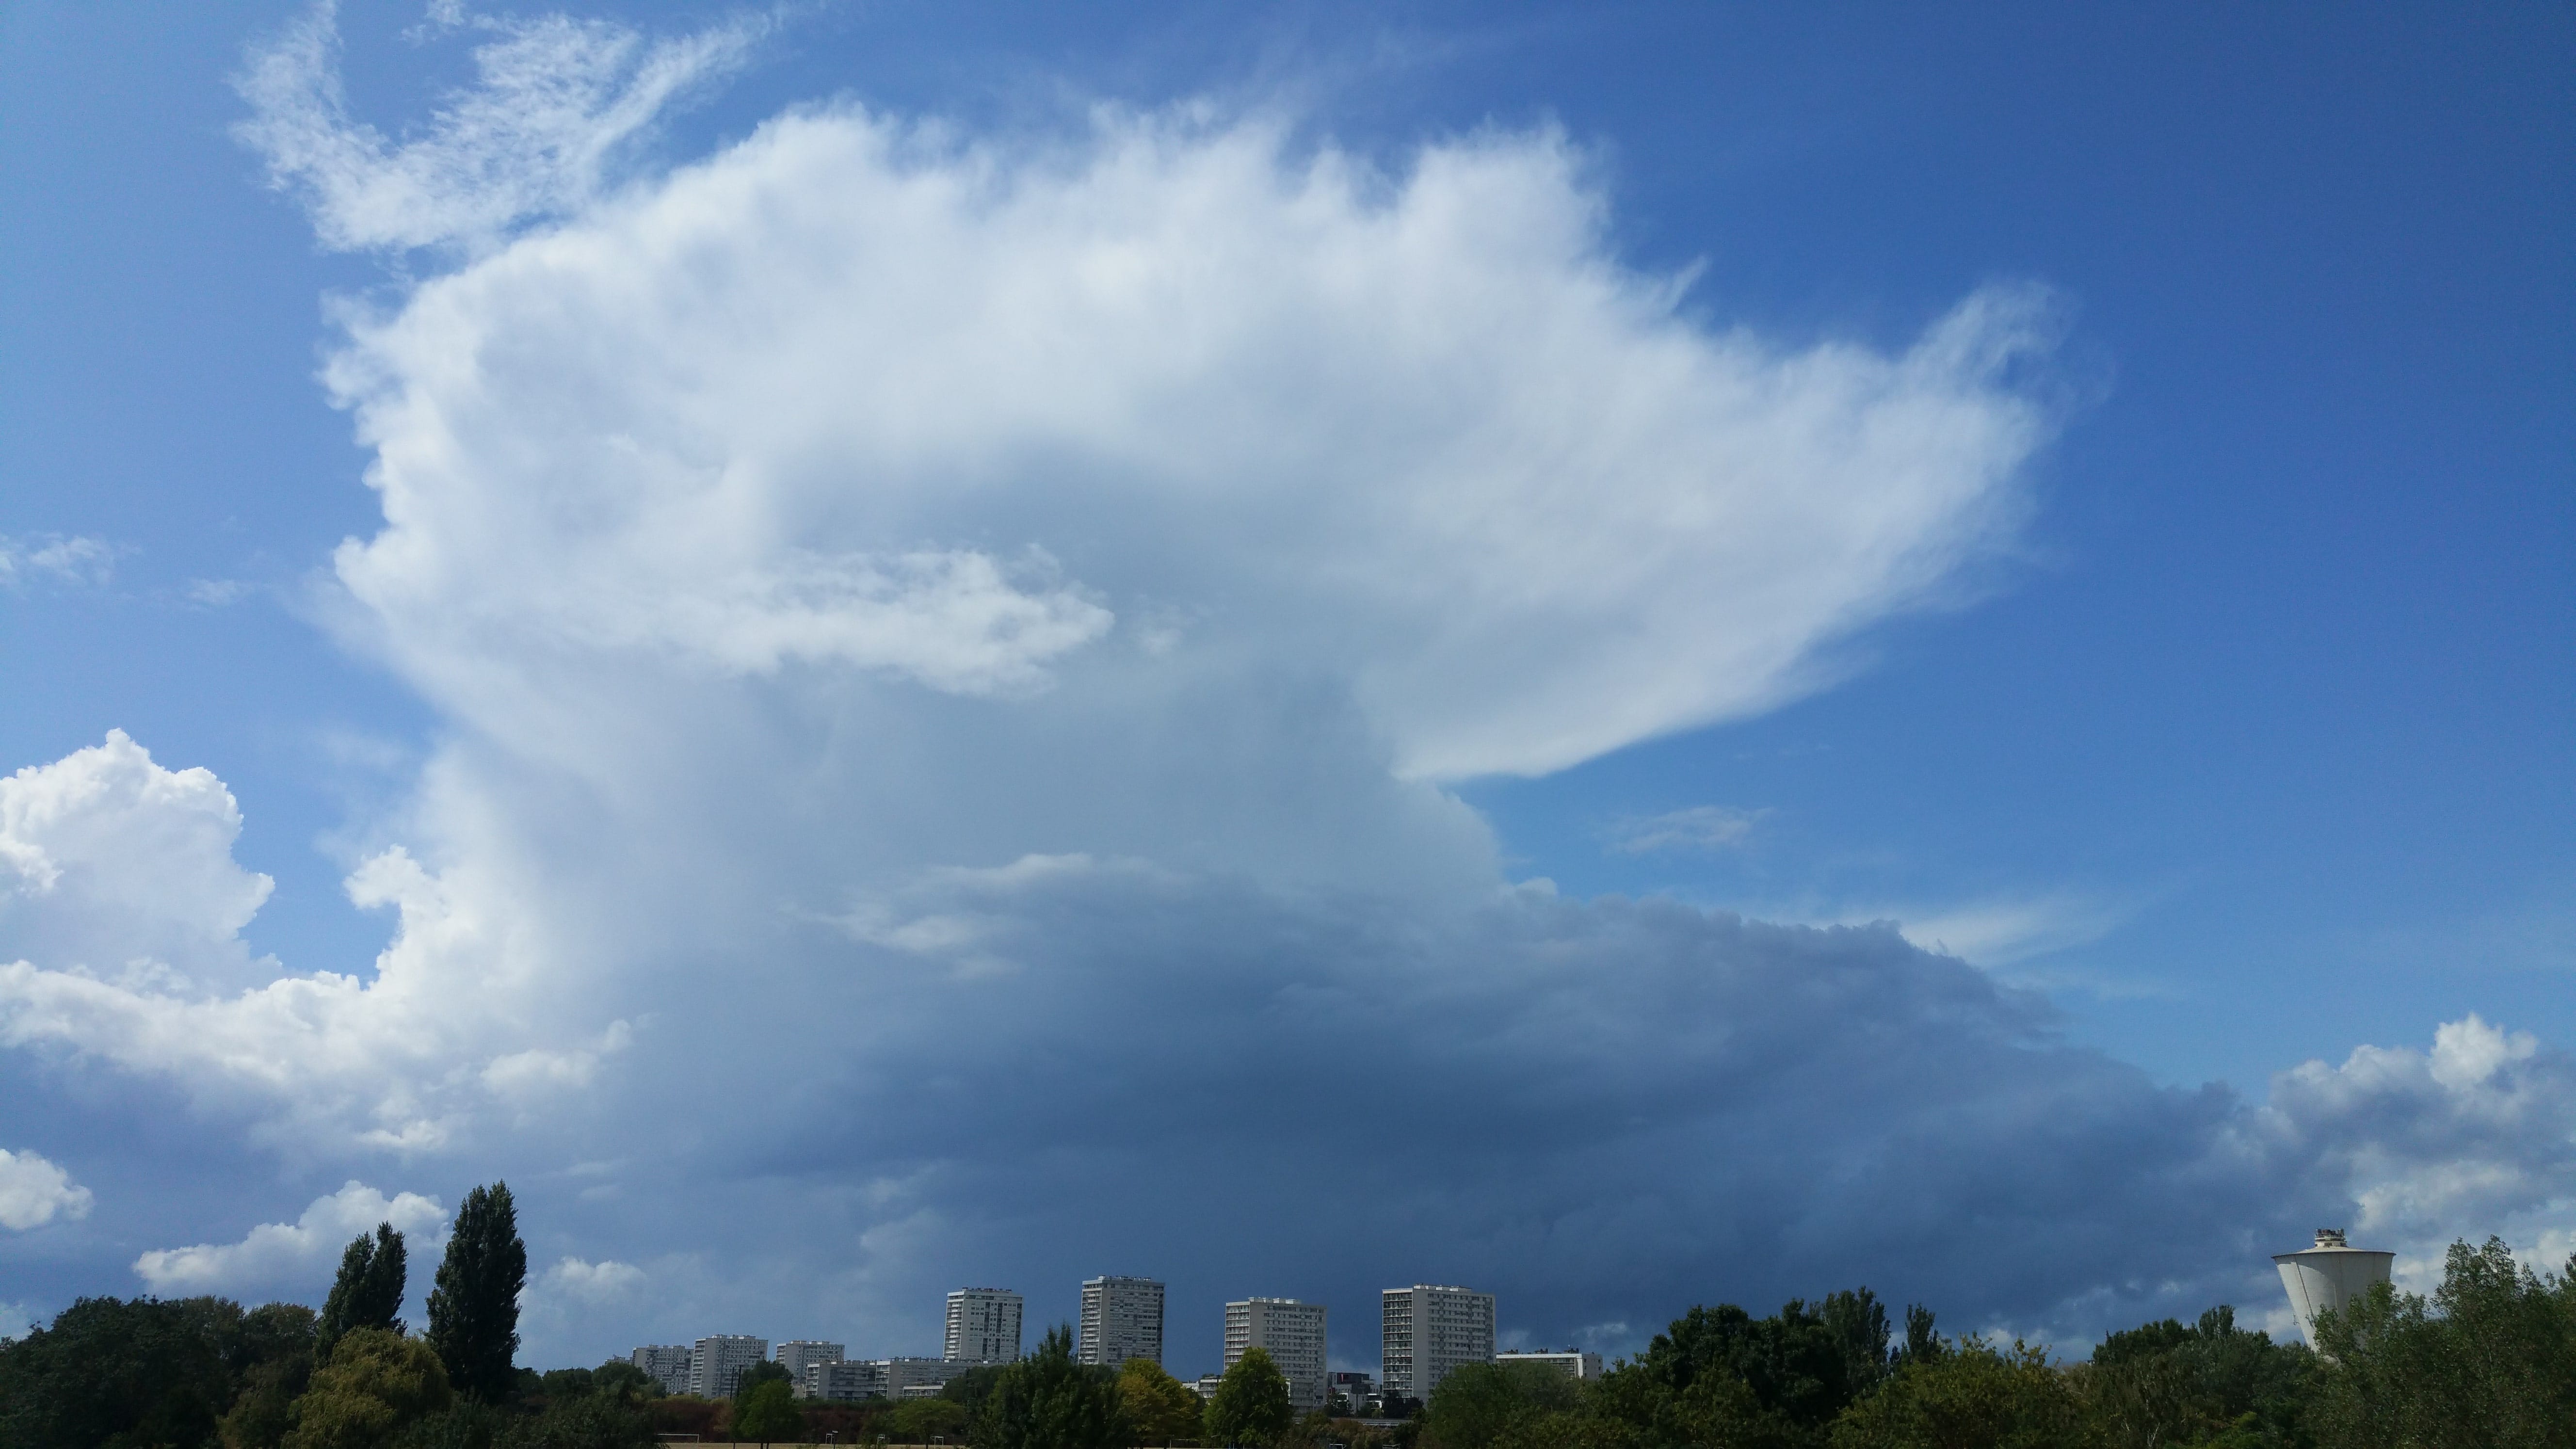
[1832,1338,2099,1449]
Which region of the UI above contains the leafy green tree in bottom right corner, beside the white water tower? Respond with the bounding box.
[2313,1238,2576,1449]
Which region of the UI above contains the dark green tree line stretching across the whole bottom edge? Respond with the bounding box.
[0,1227,2576,1449]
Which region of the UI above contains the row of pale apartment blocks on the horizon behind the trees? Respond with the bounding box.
[634,1276,1600,1413]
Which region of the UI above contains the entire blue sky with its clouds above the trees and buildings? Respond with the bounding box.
[0,5,2576,1369]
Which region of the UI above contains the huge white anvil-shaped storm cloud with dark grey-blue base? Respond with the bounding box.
[0,13,2571,1361]
